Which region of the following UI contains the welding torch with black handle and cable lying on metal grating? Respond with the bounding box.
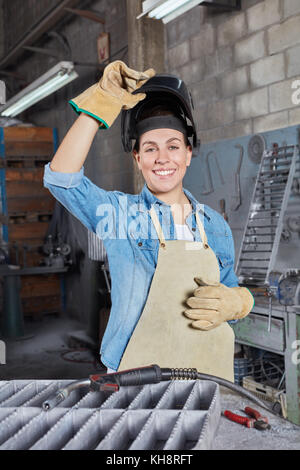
[42,364,279,416]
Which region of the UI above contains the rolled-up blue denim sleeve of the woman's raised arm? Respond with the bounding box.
[44,163,115,238]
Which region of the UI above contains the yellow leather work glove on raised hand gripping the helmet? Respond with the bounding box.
[69,60,155,128]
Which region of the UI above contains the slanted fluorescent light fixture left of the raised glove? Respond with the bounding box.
[0,61,78,117]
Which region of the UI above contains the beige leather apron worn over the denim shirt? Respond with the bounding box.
[118,207,234,382]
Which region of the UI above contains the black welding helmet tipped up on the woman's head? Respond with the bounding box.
[121,73,200,152]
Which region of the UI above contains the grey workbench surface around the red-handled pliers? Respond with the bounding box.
[212,387,300,450]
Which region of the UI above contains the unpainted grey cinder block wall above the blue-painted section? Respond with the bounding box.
[166,0,300,142]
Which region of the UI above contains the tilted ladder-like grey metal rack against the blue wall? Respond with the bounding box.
[236,144,299,285]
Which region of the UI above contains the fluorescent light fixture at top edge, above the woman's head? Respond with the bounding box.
[138,0,204,23]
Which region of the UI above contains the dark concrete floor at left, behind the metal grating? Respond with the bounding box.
[0,315,104,380]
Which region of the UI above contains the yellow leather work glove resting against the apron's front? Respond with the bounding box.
[184,278,254,331]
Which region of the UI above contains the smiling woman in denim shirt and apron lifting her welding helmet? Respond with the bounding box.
[44,61,253,380]
